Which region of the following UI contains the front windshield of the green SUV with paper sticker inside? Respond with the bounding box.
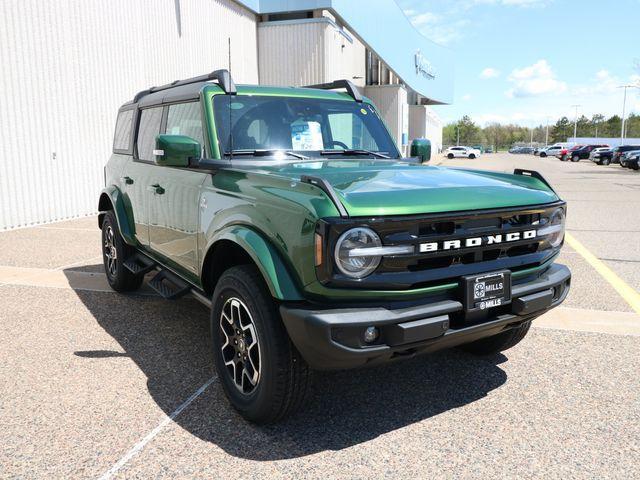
[213,95,400,158]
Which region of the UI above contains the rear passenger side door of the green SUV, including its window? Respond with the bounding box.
[121,107,162,246]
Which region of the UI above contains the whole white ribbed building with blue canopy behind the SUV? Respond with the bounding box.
[0,0,453,230]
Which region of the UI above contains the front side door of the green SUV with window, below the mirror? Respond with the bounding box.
[149,101,210,274]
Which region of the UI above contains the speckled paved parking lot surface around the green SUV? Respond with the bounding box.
[0,154,640,479]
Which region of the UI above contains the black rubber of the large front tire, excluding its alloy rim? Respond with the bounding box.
[211,265,312,424]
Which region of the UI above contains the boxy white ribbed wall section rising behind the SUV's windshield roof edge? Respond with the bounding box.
[258,17,365,86]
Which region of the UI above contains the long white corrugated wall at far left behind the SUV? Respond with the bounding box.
[0,0,258,230]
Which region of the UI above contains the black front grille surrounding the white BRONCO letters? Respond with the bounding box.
[317,203,561,289]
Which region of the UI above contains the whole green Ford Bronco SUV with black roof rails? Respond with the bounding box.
[99,70,571,423]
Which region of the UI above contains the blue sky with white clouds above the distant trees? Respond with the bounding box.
[397,0,640,126]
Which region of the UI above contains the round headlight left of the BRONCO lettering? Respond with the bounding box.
[335,227,382,278]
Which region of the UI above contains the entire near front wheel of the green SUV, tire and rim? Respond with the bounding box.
[211,265,311,424]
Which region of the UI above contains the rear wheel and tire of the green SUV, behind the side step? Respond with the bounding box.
[102,210,144,292]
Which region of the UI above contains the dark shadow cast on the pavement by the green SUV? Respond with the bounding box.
[69,266,507,461]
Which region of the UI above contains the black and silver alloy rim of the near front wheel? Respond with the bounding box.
[220,297,261,395]
